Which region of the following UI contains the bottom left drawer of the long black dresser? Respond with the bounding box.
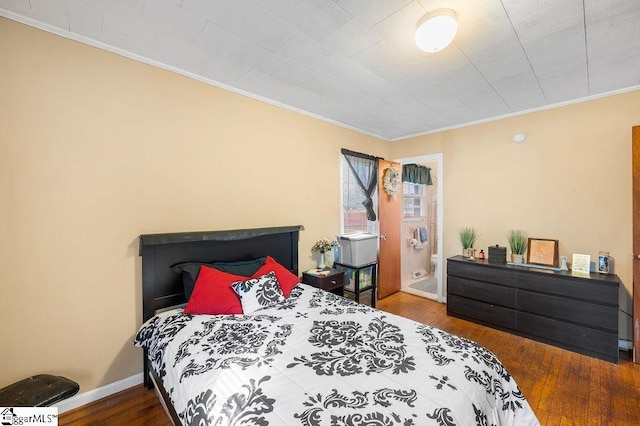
[447,294,516,329]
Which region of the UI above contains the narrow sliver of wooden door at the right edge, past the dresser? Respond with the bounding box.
[631,126,640,363]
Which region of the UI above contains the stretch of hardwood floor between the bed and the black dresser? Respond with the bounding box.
[378,293,640,425]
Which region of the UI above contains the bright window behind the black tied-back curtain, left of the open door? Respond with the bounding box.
[341,156,378,234]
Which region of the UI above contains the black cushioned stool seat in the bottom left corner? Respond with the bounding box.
[0,374,80,407]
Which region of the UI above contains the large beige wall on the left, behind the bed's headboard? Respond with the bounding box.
[0,18,390,392]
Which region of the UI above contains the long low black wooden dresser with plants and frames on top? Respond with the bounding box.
[447,256,620,364]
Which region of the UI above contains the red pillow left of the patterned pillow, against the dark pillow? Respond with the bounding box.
[184,265,249,315]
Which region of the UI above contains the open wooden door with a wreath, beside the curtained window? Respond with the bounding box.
[378,159,402,299]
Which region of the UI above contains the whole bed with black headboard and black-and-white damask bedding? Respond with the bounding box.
[134,226,539,426]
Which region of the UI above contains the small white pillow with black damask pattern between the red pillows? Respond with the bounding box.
[231,271,285,314]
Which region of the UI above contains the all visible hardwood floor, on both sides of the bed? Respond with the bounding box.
[59,293,640,426]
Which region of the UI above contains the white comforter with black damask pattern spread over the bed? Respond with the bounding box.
[135,284,538,426]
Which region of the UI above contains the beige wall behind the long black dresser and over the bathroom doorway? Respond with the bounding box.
[392,91,640,339]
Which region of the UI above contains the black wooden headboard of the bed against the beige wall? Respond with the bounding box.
[140,225,304,322]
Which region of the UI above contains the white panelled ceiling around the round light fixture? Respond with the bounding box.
[0,0,640,140]
